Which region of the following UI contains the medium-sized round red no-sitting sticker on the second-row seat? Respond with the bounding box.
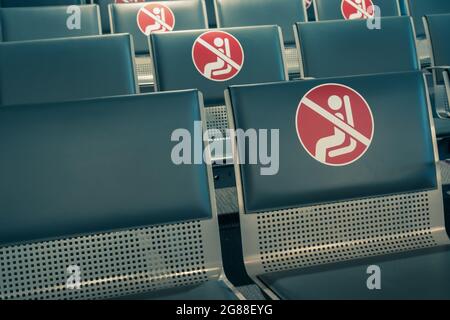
[192,31,244,81]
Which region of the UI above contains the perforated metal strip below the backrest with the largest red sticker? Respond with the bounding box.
[241,190,448,275]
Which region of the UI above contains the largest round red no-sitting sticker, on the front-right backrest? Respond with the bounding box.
[296,83,374,166]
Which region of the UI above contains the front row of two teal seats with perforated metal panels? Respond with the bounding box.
[0,72,450,299]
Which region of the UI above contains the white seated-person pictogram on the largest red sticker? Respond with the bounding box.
[316,95,357,162]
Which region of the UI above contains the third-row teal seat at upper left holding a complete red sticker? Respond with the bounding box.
[109,0,208,85]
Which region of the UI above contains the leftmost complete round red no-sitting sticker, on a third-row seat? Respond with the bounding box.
[137,2,175,36]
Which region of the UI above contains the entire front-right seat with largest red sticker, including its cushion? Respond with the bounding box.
[227,71,450,299]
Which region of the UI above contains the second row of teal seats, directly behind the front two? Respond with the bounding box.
[0,15,450,149]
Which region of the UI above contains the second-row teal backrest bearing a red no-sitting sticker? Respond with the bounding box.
[150,26,287,106]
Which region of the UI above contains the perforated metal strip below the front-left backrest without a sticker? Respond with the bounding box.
[0,220,221,300]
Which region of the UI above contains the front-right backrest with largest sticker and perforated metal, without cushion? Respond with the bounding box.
[229,72,448,275]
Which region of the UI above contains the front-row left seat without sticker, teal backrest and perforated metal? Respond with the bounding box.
[0,90,243,300]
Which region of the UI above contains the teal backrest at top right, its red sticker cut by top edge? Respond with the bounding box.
[314,0,401,21]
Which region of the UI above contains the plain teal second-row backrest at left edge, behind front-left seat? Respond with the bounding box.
[0,34,139,106]
